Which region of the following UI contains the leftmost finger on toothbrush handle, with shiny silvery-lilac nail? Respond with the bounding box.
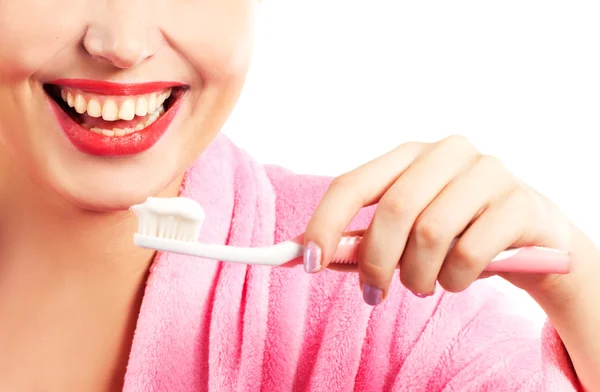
[303,143,426,272]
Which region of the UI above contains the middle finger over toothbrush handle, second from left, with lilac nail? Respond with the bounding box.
[359,138,479,304]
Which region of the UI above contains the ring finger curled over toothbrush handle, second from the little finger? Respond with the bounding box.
[400,156,517,296]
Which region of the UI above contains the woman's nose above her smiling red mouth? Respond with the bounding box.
[83,0,164,69]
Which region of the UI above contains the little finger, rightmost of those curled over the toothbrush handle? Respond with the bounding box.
[438,187,534,292]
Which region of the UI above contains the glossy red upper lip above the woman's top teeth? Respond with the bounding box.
[48,79,185,95]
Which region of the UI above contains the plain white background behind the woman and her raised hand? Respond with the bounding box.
[224,0,600,321]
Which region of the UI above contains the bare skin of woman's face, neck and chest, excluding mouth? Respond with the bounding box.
[0,0,258,392]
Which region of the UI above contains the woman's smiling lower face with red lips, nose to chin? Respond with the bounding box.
[0,0,258,210]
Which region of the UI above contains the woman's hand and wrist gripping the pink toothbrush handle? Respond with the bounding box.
[305,136,600,391]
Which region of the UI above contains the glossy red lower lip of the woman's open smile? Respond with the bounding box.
[47,94,184,157]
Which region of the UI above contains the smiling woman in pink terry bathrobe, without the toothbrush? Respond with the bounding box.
[0,0,600,391]
